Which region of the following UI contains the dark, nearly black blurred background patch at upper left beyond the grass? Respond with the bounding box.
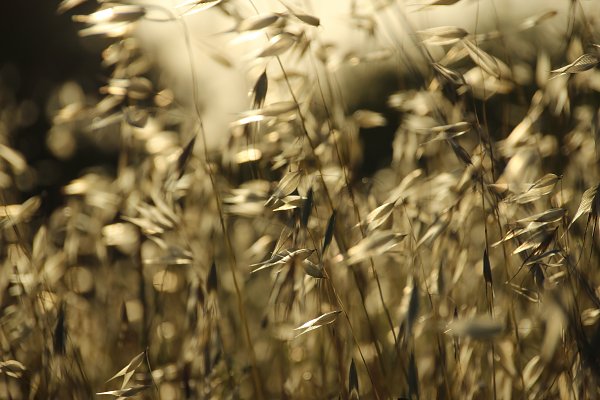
[0,0,116,213]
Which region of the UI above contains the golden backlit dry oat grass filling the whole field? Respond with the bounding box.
[0,0,600,399]
